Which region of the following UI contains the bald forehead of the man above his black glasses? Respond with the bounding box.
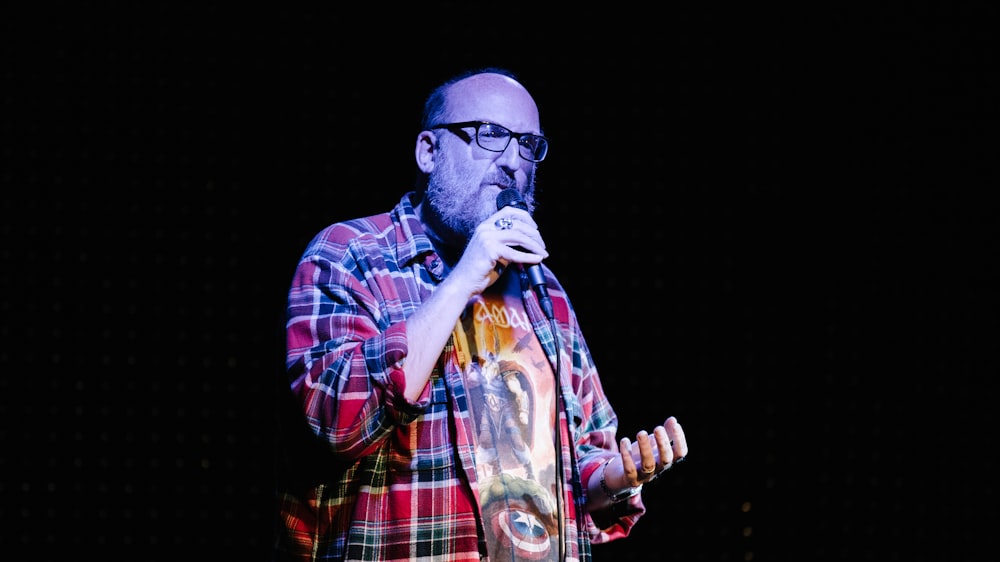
[447,74,540,133]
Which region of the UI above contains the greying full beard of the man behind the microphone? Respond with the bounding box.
[425,153,535,249]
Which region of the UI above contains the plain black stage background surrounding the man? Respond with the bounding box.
[0,2,998,562]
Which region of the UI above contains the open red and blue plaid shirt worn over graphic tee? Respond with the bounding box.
[275,193,645,562]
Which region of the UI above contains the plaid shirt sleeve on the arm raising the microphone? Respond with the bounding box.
[286,219,429,459]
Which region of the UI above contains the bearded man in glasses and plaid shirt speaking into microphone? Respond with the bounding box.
[275,69,688,562]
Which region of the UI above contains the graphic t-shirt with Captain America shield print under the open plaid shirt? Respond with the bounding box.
[456,274,559,562]
